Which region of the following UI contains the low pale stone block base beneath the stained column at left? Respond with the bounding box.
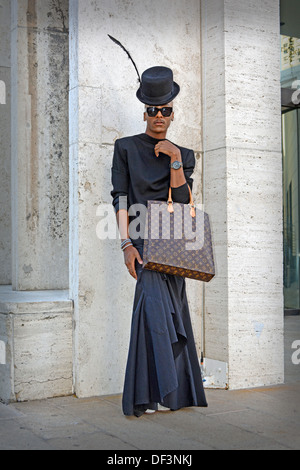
[0,286,73,403]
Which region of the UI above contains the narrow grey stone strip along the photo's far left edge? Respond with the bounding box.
[0,0,11,285]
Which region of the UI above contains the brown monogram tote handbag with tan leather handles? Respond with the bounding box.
[143,186,215,282]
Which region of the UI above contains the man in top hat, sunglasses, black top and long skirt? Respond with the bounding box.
[111,67,207,417]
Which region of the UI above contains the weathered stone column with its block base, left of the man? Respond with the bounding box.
[0,0,73,402]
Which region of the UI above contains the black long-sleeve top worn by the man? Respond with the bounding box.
[111,134,195,245]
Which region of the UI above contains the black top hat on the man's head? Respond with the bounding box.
[136,67,180,106]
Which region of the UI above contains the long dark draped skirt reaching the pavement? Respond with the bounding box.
[122,244,207,417]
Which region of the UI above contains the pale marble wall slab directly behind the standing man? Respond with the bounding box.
[70,0,202,396]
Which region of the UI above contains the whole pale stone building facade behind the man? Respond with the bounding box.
[0,0,298,402]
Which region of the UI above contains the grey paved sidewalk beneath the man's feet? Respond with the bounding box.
[0,317,300,452]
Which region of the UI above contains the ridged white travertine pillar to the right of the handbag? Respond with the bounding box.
[201,0,284,389]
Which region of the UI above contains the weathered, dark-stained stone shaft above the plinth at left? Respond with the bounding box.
[11,0,69,290]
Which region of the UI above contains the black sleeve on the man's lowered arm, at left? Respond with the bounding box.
[111,140,129,213]
